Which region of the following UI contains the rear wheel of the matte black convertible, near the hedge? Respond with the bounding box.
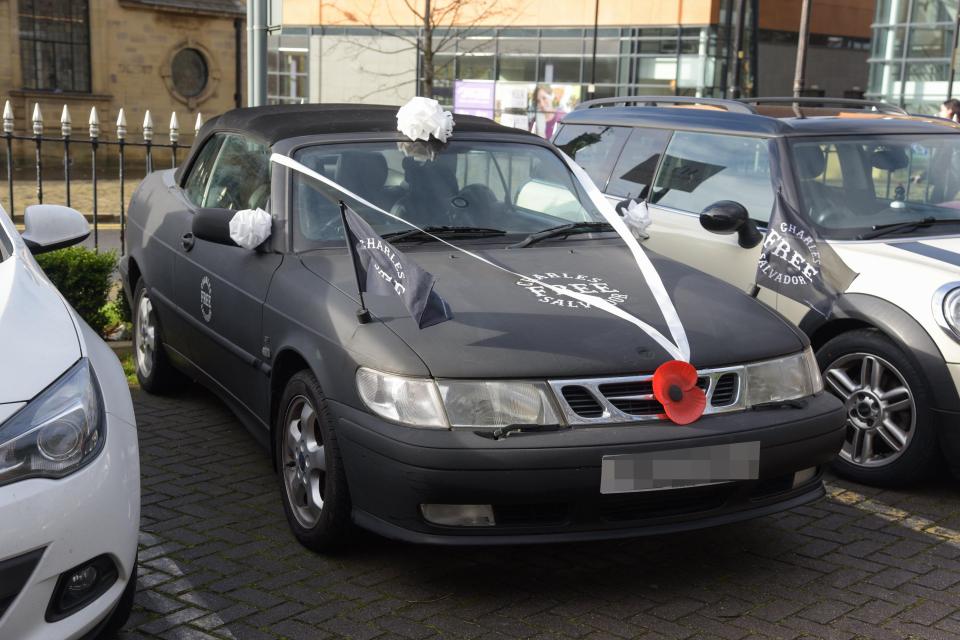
[133,279,186,394]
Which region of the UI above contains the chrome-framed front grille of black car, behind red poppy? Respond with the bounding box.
[550,367,742,424]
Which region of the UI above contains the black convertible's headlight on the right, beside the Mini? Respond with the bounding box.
[745,347,823,406]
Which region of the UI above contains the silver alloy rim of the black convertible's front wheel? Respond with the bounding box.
[281,395,327,529]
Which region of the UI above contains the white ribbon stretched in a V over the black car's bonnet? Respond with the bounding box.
[270,153,690,362]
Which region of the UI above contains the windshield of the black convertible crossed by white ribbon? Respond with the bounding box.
[293,140,604,251]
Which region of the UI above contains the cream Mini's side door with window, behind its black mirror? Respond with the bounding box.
[644,131,774,302]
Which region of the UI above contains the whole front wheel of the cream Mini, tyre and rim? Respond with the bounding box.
[817,329,939,487]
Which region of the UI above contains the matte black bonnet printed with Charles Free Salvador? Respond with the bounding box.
[301,240,804,378]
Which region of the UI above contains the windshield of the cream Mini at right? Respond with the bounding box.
[790,134,960,239]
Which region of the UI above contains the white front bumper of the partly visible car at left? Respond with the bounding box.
[0,358,140,640]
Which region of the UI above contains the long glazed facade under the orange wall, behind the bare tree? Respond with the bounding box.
[268,0,758,110]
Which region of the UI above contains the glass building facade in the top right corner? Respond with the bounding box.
[867,0,960,114]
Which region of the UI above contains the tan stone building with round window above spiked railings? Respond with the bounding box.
[0,0,246,143]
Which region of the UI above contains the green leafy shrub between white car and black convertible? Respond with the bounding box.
[37,247,122,335]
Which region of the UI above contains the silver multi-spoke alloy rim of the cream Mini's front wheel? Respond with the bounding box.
[823,353,917,467]
